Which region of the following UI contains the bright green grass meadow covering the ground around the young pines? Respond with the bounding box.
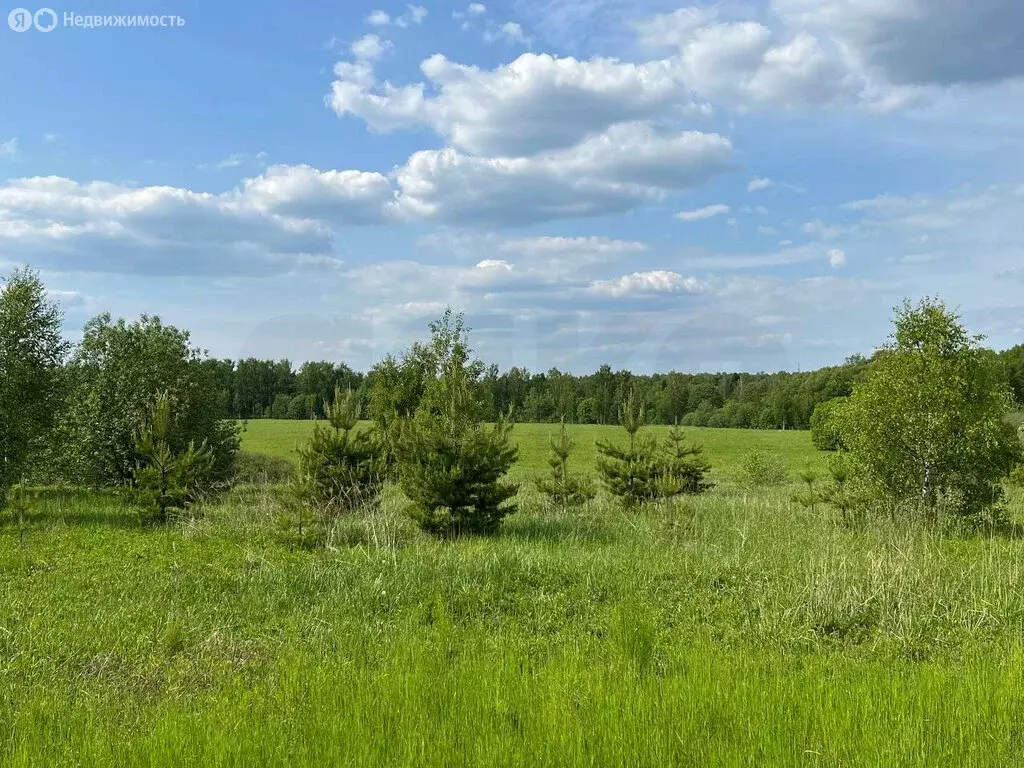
[0,422,1024,766]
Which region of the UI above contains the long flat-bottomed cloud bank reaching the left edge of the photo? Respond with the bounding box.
[0,167,393,274]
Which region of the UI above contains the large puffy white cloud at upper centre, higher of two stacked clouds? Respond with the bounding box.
[328,53,702,157]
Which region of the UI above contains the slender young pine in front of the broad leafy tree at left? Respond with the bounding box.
[134,392,214,523]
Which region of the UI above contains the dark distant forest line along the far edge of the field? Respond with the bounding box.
[207,345,1024,429]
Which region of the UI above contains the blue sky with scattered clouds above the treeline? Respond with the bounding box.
[0,0,1024,373]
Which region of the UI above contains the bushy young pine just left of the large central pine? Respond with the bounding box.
[296,389,383,520]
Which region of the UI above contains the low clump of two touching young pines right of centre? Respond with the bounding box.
[597,394,711,508]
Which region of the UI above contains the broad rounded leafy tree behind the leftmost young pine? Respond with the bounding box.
[60,314,239,486]
